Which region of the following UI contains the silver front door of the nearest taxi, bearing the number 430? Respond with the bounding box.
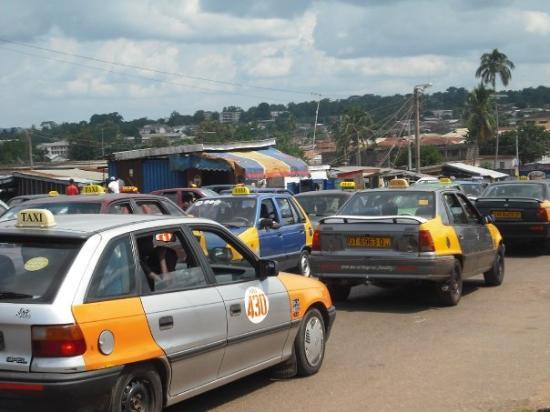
[190,224,290,377]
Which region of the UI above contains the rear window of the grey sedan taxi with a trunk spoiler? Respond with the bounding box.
[340,190,435,219]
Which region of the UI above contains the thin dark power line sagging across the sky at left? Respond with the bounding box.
[0,38,320,95]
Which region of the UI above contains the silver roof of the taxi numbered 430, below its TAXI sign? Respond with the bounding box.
[0,214,215,239]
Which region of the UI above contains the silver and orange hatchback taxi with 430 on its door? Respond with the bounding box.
[0,209,335,412]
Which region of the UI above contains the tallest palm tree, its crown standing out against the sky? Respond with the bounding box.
[476,49,516,169]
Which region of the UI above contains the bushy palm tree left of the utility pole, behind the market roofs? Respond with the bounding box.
[336,107,373,166]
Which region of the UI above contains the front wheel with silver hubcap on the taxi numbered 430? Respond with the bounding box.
[294,308,327,376]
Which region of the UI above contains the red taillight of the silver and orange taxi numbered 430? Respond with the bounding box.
[32,325,86,358]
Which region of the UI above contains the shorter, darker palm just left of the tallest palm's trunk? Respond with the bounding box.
[464,83,495,164]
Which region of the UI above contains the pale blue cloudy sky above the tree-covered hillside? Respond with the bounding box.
[0,0,550,127]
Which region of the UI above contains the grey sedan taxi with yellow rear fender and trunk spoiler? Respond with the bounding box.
[311,179,504,305]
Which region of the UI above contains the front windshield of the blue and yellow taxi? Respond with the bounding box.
[187,197,256,227]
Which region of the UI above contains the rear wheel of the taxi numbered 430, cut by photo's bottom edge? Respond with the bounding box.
[108,366,163,412]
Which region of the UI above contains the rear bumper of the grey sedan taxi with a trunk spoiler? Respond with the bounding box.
[311,252,455,283]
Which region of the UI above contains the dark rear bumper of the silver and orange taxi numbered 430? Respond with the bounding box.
[0,367,123,411]
